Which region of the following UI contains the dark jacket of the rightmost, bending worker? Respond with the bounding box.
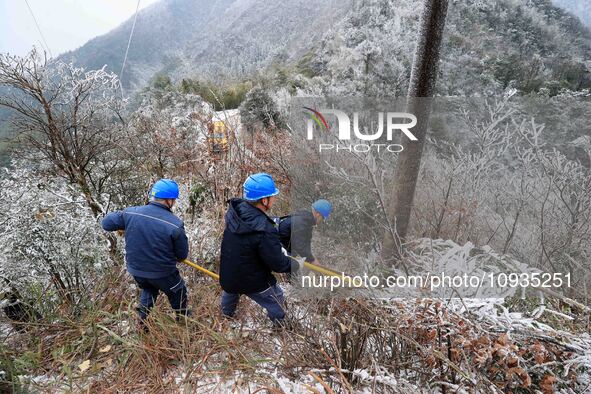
[279,209,316,263]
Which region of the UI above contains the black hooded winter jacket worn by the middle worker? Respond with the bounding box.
[220,198,292,294]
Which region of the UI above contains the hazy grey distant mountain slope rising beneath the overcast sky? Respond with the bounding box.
[63,0,350,87]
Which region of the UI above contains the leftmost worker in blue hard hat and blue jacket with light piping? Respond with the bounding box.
[102,179,189,331]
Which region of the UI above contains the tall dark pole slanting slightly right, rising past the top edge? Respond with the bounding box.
[382,0,448,262]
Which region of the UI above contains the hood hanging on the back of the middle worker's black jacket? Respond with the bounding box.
[225,198,273,234]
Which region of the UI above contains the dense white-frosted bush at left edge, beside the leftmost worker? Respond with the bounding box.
[0,161,109,306]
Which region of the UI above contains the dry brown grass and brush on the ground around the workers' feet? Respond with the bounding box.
[4,270,588,393]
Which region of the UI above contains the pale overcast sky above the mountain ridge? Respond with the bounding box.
[0,0,158,56]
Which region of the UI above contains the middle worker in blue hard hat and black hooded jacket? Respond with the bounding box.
[220,173,302,326]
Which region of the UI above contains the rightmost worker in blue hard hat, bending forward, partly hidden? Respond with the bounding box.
[279,200,332,263]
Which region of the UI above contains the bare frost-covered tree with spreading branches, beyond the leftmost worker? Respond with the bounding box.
[0,49,131,257]
